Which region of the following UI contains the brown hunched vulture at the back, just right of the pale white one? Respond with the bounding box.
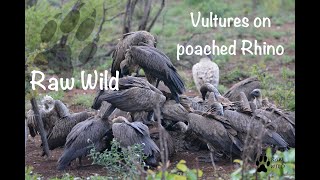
[223,77,261,101]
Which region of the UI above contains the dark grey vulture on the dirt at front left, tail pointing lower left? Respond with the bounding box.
[57,102,113,170]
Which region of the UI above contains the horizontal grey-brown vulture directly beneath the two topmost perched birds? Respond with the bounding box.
[92,76,166,120]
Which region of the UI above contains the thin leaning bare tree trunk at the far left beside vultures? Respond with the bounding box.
[30,98,50,157]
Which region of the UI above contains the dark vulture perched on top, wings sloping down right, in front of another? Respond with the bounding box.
[120,46,185,103]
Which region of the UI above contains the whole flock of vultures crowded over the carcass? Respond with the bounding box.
[26,31,295,170]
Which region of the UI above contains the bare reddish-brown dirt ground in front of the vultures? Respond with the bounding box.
[25,136,236,179]
